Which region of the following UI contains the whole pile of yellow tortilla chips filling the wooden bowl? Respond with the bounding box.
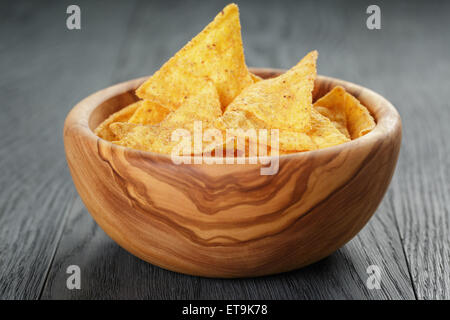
[95,4,375,155]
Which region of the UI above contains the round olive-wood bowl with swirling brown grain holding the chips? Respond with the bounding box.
[64,69,401,278]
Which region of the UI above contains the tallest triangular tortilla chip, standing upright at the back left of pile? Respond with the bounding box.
[136,4,253,110]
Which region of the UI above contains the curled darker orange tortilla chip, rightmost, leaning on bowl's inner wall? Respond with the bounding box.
[314,86,376,139]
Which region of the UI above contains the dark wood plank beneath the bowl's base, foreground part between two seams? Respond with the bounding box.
[42,196,414,299]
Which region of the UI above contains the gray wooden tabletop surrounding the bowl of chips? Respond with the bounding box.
[0,0,450,299]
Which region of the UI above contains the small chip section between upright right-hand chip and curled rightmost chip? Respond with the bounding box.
[308,108,350,149]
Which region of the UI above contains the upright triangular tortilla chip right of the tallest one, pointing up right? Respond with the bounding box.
[225,51,317,132]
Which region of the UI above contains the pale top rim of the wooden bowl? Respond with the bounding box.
[64,68,402,162]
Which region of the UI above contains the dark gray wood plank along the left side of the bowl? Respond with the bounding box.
[0,1,139,299]
